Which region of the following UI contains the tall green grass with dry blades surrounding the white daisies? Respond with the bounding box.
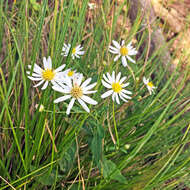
[0,0,190,190]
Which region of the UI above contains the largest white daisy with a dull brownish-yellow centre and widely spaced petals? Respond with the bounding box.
[52,74,97,115]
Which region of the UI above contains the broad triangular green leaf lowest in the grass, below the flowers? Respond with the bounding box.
[102,158,127,184]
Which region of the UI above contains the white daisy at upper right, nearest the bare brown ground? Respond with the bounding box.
[109,40,137,67]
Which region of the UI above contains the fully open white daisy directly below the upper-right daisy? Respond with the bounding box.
[101,71,132,104]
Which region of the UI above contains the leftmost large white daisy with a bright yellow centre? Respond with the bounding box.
[26,56,65,90]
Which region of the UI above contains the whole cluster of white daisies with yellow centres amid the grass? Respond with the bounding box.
[27,40,156,114]
